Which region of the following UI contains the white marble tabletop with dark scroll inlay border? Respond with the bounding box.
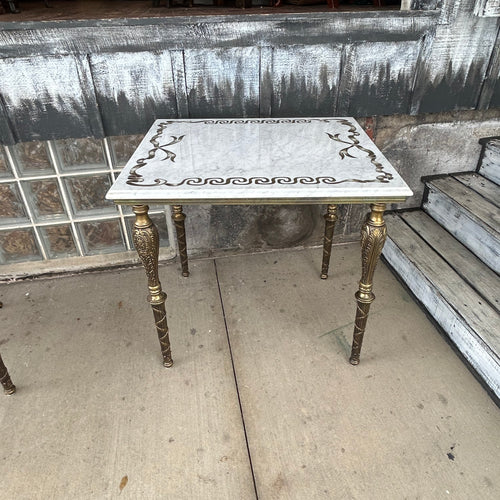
[106,118,412,204]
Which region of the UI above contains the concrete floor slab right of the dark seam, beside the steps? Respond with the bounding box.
[217,244,497,500]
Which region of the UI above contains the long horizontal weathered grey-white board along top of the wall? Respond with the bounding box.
[0,11,438,58]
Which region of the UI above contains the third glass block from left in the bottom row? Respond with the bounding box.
[78,219,125,254]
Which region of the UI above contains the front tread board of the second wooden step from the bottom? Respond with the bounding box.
[427,176,500,235]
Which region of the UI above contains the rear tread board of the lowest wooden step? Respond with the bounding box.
[399,210,500,312]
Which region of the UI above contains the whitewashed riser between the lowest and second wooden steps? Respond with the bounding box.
[423,185,500,273]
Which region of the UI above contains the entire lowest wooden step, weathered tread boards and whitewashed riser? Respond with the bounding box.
[383,212,500,397]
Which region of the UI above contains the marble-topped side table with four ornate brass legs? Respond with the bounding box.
[106,117,412,367]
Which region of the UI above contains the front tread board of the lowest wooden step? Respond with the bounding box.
[386,214,500,363]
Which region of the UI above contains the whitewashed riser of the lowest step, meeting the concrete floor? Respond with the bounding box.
[383,237,500,397]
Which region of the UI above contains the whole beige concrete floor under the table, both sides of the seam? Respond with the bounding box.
[0,245,500,500]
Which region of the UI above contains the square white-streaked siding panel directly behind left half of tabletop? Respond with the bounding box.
[184,47,260,118]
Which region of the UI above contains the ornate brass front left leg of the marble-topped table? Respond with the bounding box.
[132,205,173,368]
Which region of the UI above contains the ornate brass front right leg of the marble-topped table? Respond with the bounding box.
[349,203,387,365]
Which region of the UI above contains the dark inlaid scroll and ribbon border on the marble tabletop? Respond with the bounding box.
[127,118,393,187]
